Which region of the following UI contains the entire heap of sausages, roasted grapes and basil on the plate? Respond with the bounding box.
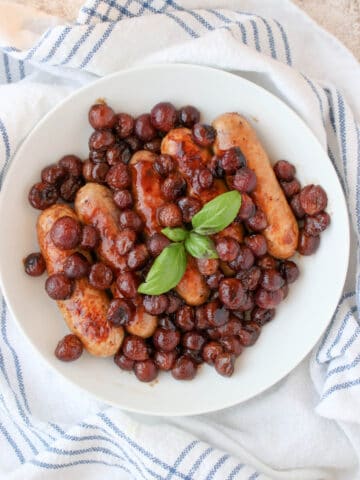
[24,101,330,382]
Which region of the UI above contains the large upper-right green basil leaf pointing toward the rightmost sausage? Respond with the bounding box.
[192,190,241,235]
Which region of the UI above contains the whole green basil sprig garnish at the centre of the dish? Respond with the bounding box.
[138,190,241,295]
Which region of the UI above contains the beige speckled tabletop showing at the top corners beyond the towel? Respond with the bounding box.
[7,0,360,60]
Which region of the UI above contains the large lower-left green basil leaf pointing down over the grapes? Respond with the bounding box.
[138,243,186,295]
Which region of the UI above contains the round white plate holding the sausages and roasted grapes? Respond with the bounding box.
[0,65,349,415]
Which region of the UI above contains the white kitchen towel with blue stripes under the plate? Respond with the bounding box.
[0,0,360,480]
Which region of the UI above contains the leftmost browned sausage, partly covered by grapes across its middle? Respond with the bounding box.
[37,204,124,357]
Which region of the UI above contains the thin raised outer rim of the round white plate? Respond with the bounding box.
[0,63,350,417]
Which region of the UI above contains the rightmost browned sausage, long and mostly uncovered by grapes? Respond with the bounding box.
[213,113,299,258]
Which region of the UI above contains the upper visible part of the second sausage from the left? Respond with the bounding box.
[75,183,127,271]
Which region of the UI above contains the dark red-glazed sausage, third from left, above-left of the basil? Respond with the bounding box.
[130,150,166,235]
